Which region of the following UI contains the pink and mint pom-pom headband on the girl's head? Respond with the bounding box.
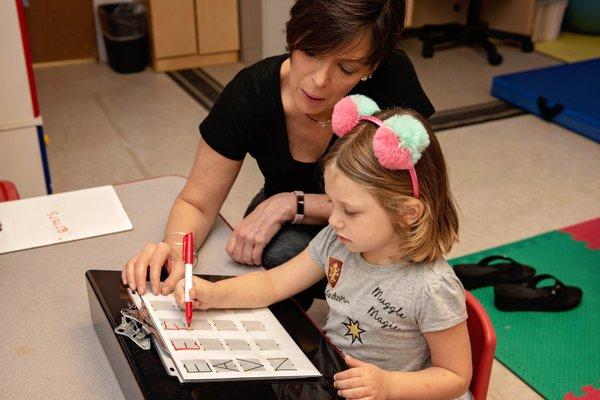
[331,94,429,198]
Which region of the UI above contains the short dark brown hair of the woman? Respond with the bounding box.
[286,0,406,68]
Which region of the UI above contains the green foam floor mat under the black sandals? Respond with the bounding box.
[450,231,600,399]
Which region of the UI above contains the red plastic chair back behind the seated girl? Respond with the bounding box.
[466,291,496,400]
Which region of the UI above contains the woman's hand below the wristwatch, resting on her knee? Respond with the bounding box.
[225,193,296,265]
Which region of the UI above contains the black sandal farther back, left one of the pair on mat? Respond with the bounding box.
[454,256,535,290]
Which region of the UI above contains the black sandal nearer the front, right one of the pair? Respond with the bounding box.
[494,274,583,311]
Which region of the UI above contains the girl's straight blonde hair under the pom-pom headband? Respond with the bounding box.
[323,108,458,262]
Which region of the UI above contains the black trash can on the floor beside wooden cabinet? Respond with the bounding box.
[98,3,148,73]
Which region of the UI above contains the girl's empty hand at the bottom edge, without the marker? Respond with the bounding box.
[333,355,390,400]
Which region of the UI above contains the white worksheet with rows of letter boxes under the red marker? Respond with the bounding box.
[141,293,321,382]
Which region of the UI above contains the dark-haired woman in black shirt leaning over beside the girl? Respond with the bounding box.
[122,0,434,309]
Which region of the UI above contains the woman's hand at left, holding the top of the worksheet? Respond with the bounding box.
[121,242,185,295]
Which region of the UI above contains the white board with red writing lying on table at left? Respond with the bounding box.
[0,186,133,254]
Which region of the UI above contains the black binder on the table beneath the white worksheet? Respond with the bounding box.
[85,270,347,400]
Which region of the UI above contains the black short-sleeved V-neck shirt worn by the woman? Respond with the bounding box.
[200,50,435,197]
